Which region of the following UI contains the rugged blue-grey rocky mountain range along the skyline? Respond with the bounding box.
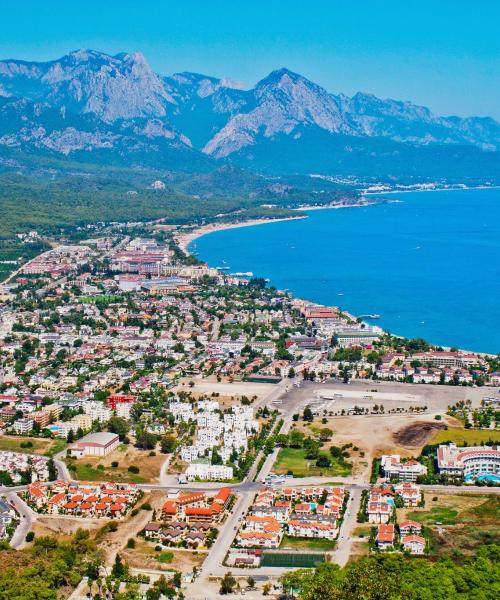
[0,50,500,180]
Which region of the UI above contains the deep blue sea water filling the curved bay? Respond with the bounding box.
[190,189,500,353]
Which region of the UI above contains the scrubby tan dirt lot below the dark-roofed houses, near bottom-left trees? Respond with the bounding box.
[120,538,207,573]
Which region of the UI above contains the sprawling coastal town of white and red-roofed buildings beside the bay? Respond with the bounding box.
[0,224,500,600]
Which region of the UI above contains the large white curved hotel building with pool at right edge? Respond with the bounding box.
[437,444,500,478]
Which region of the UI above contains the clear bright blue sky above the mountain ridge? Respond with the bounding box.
[0,0,500,119]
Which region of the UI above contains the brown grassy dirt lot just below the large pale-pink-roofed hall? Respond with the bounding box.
[68,444,167,483]
